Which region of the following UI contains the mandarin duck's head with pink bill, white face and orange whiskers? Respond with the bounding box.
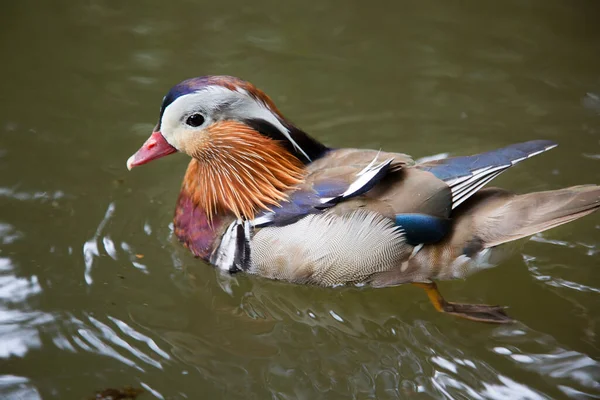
[127,76,327,218]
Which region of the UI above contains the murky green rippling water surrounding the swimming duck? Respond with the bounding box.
[0,0,600,399]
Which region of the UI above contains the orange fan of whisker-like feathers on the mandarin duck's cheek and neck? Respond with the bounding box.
[173,121,305,223]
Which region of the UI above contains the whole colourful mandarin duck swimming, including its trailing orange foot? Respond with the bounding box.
[127,76,600,324]
